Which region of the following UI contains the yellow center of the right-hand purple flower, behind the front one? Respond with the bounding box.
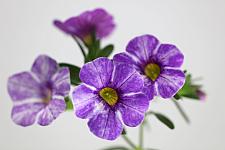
[145,63,160,81]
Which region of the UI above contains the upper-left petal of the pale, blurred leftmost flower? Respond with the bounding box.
[8,72,44,101]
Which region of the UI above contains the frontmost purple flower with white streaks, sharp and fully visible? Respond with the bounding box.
[73,57,149,140]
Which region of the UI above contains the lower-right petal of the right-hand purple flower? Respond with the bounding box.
[156,69,185,98]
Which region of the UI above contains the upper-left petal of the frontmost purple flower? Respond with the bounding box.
[80,57,113,89]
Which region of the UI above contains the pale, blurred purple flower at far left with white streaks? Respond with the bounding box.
[8,55,70,126]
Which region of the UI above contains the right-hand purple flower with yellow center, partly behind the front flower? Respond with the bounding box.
[113,35,185,99]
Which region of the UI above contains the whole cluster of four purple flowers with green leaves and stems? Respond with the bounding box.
[8,9,206,149]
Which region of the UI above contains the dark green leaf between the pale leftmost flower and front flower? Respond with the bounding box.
[59,63,81,85]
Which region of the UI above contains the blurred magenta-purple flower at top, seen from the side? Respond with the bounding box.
[54,8,115,44]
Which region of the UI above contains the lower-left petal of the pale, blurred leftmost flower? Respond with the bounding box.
[11,103,44,127]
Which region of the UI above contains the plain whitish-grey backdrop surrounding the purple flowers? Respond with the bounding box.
[0,0,225,150]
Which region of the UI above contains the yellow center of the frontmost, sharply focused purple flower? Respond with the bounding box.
[99,87,118,106]
